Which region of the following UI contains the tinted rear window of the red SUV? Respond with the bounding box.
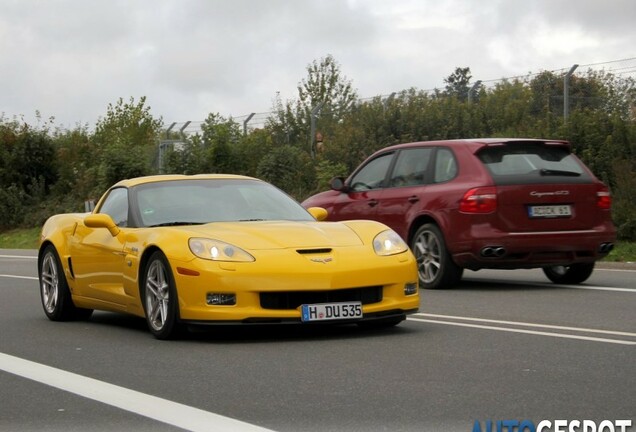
[477,142,591,185]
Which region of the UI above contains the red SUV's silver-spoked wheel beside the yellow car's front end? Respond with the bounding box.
[411,223,464,289]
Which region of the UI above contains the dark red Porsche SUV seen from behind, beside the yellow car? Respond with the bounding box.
[302,138,616,289]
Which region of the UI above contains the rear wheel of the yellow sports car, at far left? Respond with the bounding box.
[38,245,93,321]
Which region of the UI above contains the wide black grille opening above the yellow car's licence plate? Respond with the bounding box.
[260,285,382,309]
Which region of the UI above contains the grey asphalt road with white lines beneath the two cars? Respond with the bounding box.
[0,250,636,432]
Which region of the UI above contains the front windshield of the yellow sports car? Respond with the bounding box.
[134,179,314,226]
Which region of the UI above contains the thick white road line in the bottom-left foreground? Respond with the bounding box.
[0,353,270,432]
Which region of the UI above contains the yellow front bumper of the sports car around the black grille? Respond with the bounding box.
[171,248,420,325]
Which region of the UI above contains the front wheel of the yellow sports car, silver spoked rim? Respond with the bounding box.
[142,251,181,340]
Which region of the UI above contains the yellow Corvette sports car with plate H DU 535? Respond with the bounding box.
[38,174,419,339]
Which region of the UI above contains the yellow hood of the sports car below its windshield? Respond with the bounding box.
[184,221,362,250]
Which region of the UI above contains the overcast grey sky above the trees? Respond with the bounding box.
[0,0,636,128]
